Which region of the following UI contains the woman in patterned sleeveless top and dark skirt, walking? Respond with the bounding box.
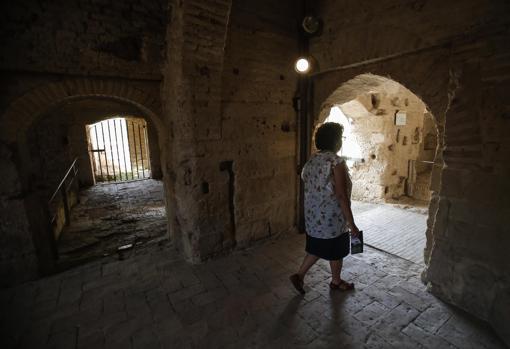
[290,122,359,293]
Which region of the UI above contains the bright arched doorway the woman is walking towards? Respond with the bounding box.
[315,74,438,264]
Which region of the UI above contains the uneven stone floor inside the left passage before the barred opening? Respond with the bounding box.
[58,179,167,267]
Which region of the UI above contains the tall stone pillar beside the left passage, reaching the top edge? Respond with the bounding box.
[162,0,231,262]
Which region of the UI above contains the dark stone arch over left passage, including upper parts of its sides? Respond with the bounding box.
[0,78,169,198]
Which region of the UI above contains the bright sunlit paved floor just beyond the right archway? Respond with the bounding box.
[352,201,428,265]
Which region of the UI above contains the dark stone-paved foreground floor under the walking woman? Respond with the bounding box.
[0,231,505,349]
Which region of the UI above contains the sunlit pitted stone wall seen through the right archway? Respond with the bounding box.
[324,96,437,207]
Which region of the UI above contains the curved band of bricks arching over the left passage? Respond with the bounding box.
[0,78,165,143]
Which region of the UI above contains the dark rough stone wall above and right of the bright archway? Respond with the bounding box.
[311,1,510,343]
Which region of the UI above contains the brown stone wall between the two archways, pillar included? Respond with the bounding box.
[163,1,296,261]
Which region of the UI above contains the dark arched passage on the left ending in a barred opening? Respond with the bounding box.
[28,98,168,269]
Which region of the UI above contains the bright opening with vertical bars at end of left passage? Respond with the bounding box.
[86,117,151,183]
